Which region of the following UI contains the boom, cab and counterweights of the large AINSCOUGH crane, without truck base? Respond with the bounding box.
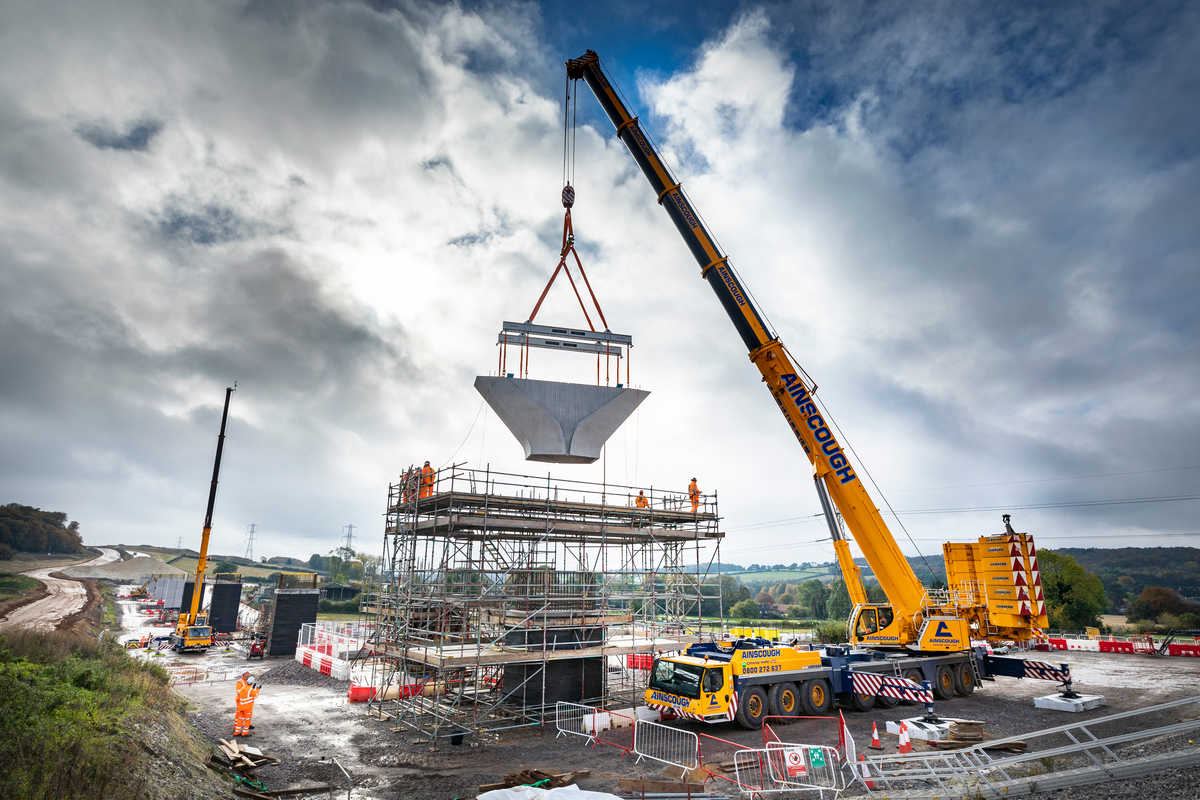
[566,50,1046,652]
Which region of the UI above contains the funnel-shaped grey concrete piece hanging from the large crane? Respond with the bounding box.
[475,375,649,464]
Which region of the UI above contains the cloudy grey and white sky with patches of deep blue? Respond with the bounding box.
[0,0,1200,564]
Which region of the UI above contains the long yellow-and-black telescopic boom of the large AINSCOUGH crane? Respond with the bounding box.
[566,50,925,621]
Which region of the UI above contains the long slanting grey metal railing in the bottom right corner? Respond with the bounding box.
[858,697,1200,798]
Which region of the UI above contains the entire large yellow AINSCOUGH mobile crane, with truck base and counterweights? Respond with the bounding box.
[566,50,1070,728]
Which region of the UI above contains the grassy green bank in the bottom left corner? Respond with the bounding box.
[0,630,181,800]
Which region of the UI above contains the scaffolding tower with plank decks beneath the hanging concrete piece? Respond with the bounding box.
[361,465,724,739]
